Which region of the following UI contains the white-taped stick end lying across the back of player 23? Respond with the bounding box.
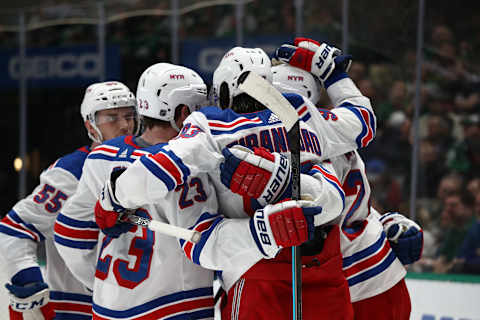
[127,215,200,243]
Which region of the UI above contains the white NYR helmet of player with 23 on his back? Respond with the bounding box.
[137,63,207,131]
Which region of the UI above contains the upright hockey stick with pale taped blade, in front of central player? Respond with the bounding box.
[238,71,302,320]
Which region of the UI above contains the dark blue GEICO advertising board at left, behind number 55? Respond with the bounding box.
[0,46,120,88]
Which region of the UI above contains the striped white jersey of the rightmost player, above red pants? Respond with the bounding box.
[326,151,406,302]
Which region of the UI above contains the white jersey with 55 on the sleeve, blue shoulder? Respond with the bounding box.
[0,147,92,319]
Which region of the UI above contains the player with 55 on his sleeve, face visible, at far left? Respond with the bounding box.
[0,81,136,320]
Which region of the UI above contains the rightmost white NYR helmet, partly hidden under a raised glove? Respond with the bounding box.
[272,64,320,104]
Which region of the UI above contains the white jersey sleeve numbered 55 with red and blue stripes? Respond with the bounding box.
[0,167,78,278]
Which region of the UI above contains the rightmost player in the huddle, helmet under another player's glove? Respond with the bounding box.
[273,38,423,320]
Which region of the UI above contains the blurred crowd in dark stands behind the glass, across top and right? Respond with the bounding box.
[0,0,480,274]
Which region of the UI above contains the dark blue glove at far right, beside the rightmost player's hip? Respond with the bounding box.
[380,212,423,265]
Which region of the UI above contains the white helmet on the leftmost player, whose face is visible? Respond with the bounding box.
[80,81,139,143]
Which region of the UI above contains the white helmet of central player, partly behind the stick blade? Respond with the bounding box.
[213,47,272,108]
